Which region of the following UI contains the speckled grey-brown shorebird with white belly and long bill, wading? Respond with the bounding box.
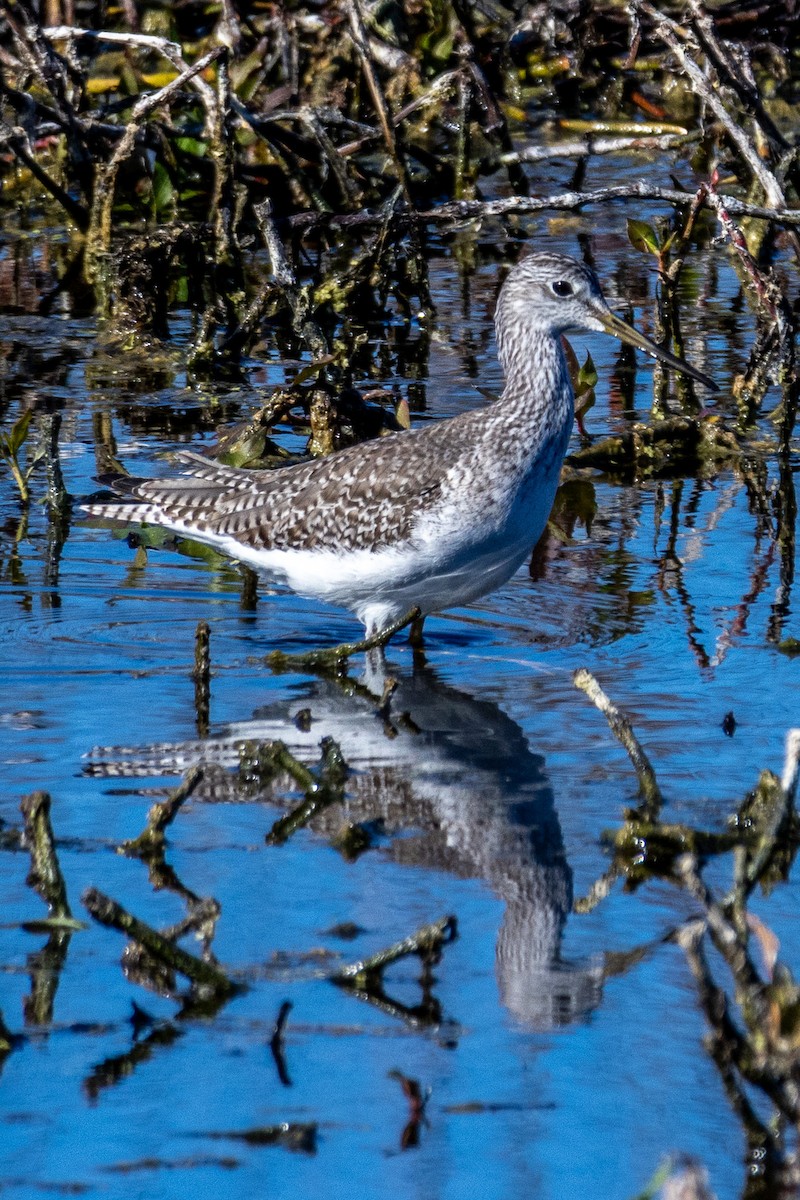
[84,252,716,636]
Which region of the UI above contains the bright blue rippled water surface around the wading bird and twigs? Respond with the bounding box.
[0,226,800,1200]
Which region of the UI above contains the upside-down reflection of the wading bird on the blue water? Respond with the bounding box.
[85,658,601,1028]
